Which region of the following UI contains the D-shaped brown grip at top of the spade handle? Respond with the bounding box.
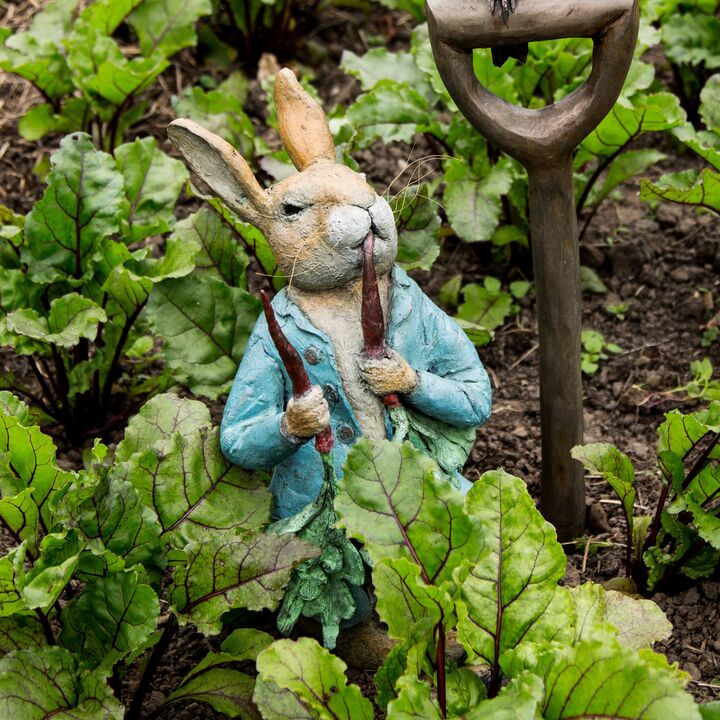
[427,0,638,168]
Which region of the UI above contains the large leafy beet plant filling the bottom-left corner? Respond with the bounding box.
[0,392,318,720]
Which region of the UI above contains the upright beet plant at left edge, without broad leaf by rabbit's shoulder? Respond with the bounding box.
[0,133,190,443]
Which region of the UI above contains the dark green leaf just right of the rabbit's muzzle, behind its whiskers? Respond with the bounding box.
[390,184,441,270]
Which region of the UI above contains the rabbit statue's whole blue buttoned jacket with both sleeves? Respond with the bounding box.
[220,266,491,519]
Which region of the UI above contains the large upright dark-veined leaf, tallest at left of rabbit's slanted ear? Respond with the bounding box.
[22,133,127,282]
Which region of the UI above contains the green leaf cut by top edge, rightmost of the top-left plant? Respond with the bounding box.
[128,0,212,57]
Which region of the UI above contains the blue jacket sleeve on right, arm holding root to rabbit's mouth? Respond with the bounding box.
[405,292,492,427]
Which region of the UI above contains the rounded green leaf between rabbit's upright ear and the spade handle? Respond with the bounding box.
[347,80,432,148]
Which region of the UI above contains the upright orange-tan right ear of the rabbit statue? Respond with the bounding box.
[275,68,335,170]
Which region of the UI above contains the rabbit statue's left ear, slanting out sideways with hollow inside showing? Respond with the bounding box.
[168,119,269,223]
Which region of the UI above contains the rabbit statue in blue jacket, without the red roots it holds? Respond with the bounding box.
[168,69,491,519]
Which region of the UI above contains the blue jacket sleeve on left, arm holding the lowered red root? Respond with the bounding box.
[220,317,302,470]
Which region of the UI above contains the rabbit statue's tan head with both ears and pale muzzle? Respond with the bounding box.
[168,68,397,290]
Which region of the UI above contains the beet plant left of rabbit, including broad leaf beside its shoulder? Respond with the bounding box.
[0,133,259,445]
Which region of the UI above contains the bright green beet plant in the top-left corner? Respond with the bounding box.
[0,0,211,151]
